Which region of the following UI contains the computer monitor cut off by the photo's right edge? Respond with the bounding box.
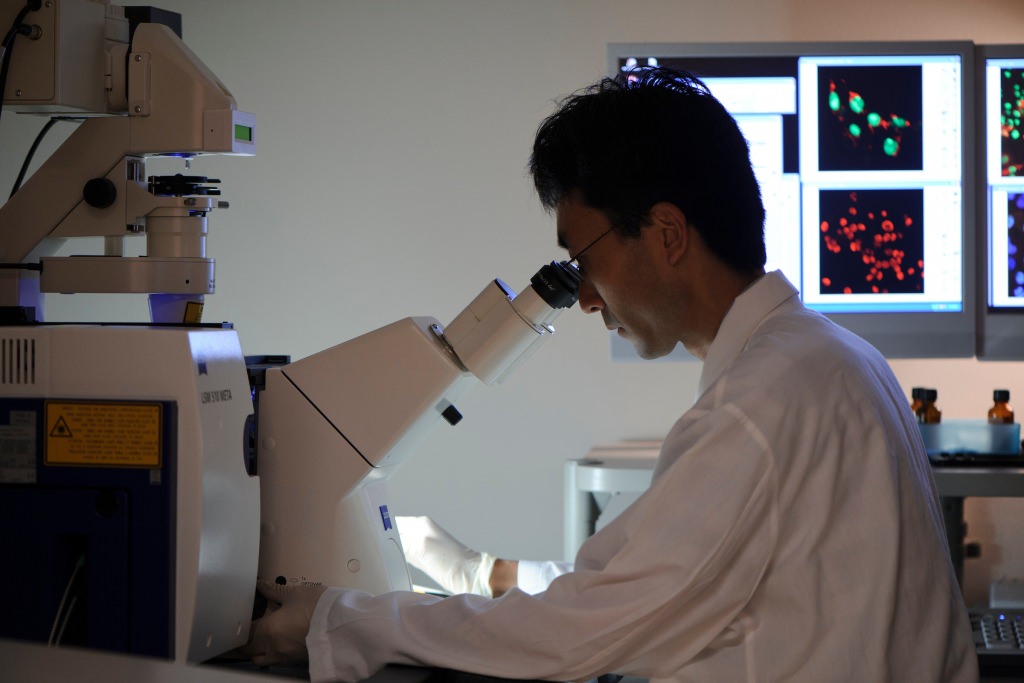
[975,45,1024,359]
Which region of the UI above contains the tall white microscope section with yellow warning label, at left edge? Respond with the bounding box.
[0,0,259,661]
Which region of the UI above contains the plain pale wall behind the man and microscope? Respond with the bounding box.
[0,0,1024,610]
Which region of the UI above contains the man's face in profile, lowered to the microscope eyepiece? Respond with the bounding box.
[555,198,679,358]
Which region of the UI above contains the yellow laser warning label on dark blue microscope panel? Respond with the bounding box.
[44,400,163,467]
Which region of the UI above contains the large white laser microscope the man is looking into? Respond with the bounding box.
[0,0,580,664]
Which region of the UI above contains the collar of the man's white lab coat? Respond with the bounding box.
[697,270,799,398]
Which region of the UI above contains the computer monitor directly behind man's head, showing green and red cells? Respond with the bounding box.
[609,42,975,357]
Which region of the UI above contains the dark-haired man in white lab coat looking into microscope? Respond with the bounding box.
[250,69,978,683]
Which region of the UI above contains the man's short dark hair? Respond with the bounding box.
[529,68,765,272]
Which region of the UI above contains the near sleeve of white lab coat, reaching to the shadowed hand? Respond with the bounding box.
[306,407,777,682]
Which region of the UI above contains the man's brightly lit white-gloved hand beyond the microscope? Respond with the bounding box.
[397,516,495,598]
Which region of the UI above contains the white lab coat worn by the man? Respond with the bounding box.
[306,272,978,683]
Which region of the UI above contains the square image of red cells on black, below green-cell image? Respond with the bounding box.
[818,189,925,294]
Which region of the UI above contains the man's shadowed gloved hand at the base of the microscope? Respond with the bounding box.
[241,581,327,667]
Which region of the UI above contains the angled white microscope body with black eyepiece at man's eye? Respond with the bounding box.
[257,263,580,593]
